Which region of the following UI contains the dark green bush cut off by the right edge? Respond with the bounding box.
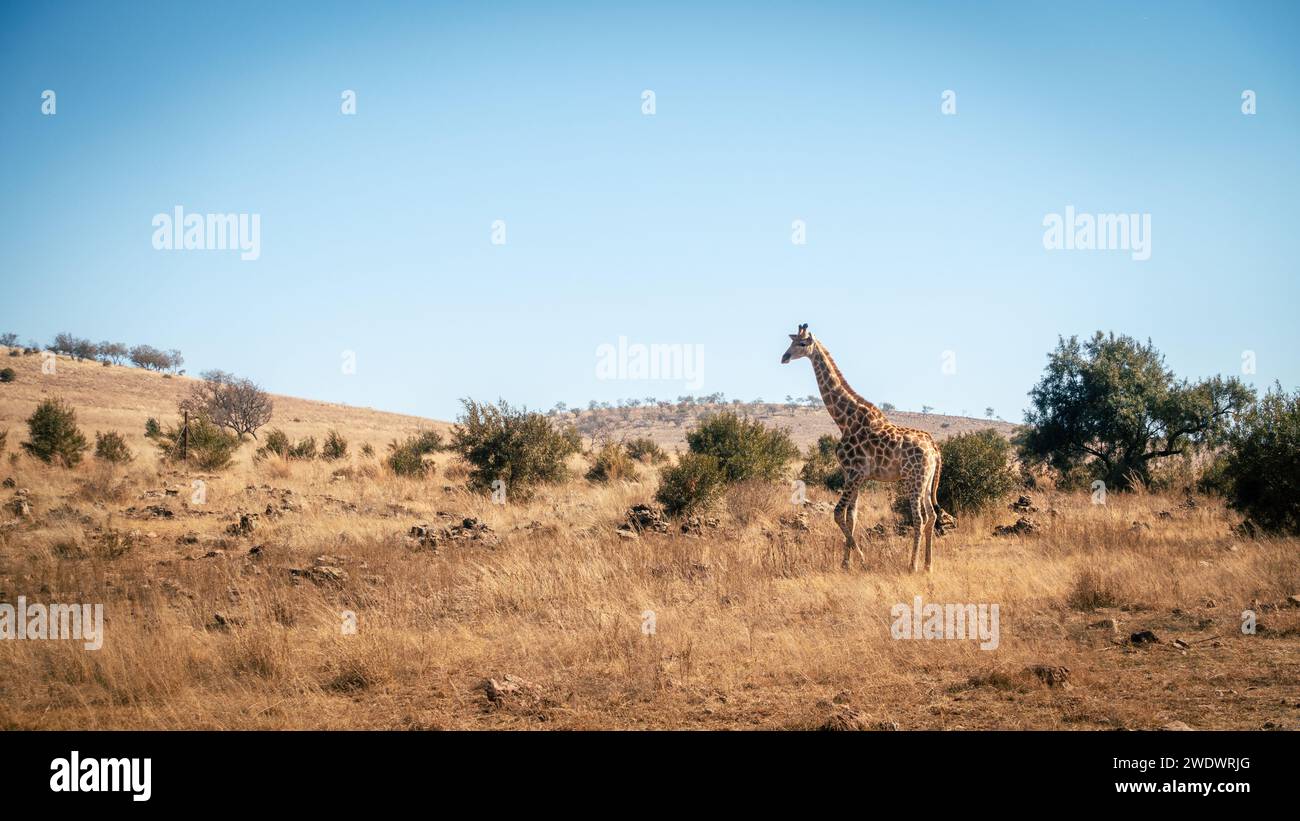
[1218,386,1300,534]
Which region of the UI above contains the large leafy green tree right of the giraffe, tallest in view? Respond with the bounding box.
[1021,331,1253,488]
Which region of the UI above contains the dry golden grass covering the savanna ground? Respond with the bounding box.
[0,357,1300,729]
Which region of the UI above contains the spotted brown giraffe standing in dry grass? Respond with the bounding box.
[781,323,943,573]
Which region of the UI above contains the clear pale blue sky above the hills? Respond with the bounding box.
[0,1,1300,420]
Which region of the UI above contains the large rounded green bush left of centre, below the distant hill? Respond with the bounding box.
[451,399,582,500]
